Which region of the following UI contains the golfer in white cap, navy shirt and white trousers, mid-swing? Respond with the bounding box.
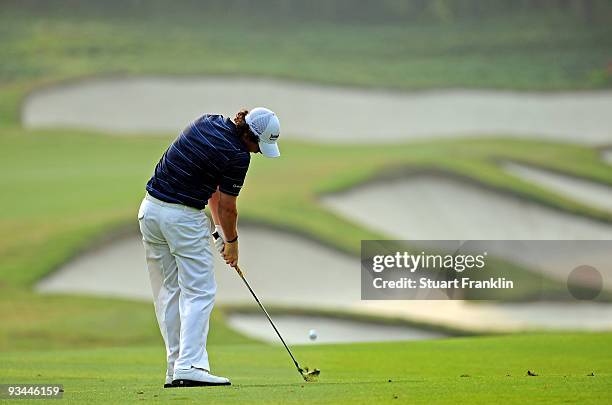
[138,107,280,388]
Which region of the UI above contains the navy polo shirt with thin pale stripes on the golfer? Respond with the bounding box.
[147,114,251,210]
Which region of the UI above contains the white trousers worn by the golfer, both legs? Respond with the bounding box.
[138,194,217,376]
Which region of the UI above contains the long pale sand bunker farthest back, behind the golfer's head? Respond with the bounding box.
[22,77,612,144]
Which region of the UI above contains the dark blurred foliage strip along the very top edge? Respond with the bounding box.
[1,0,612,24]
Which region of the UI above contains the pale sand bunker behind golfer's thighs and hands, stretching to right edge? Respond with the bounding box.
[36,226,612,333]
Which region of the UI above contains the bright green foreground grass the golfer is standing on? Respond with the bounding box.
[0,333,612,404]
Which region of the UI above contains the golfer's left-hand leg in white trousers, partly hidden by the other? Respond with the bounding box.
[139,203,181,383]
